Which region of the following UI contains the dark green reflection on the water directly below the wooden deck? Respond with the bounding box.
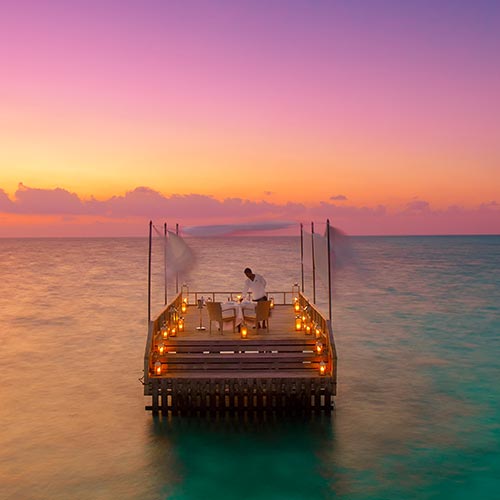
[150,413,335,499]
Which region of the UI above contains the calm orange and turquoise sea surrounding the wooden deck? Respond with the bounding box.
[0,236,500,500]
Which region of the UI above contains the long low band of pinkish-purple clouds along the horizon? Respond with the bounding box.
[0,183,500,236]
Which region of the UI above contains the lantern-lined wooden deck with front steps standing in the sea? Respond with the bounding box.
[144,294,336,413]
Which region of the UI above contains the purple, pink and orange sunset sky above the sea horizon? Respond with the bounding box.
[0,0,500,237]
